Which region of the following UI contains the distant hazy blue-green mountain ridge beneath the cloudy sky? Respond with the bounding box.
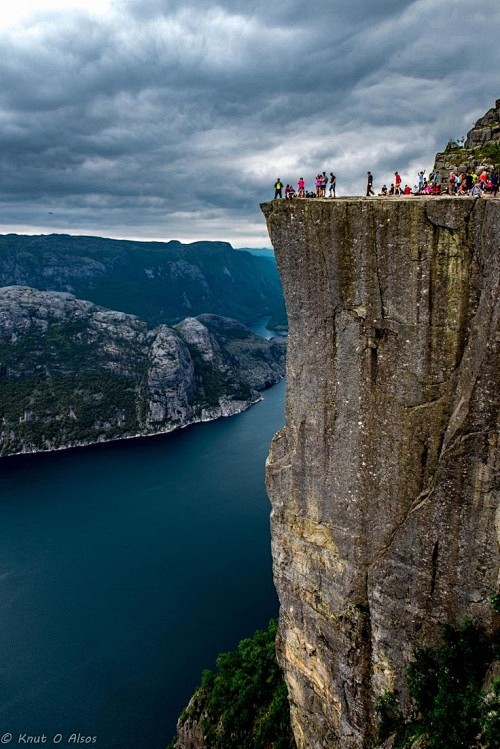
[0,234,286,326]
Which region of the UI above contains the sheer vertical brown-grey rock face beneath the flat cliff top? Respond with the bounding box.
[262,198,500,749]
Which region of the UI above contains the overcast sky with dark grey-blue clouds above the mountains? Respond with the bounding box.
[0,0,500,247]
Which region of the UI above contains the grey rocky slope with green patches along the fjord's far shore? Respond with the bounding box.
[0,286,285,455]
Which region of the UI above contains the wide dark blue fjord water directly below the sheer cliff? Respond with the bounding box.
[0,382,285,749]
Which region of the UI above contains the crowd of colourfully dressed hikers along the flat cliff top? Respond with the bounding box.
[274,169,500,200]
